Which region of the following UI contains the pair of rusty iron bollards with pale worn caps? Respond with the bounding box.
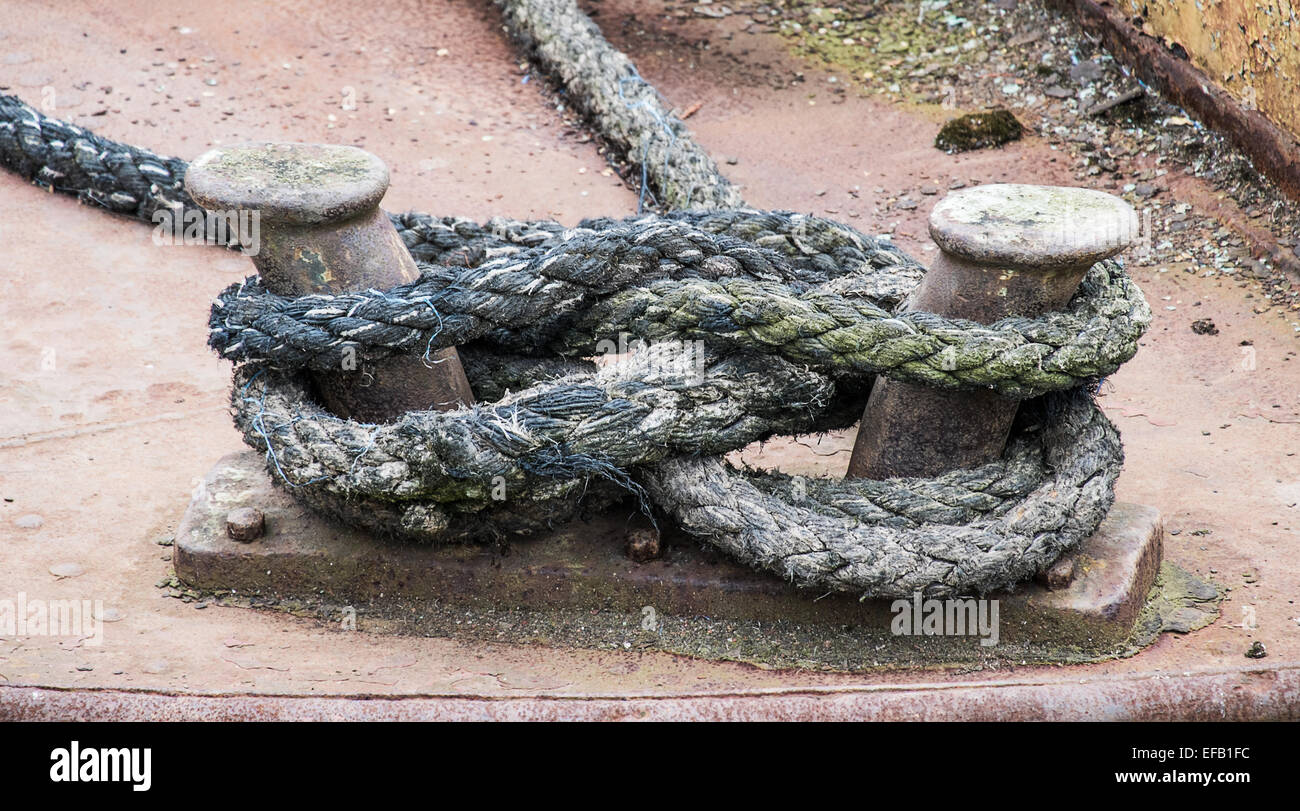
[186,144,1138,493]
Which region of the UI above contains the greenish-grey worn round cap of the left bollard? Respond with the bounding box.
[185,143,389,225]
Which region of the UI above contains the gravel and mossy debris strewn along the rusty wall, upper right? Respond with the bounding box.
[712,0,1300,330]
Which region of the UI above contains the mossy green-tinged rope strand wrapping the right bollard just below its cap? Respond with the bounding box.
[572,254,1151,399]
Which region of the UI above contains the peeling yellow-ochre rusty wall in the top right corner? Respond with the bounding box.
[1118,0,1300,136]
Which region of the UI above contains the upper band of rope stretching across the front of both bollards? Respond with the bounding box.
[209,219,1151,399]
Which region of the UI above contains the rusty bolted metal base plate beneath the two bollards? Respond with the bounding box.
[174,451,1164,669]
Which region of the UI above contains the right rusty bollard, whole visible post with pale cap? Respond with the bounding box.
[848,183,1138,478]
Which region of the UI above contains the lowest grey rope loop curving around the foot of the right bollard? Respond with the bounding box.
[644,394,1123,598]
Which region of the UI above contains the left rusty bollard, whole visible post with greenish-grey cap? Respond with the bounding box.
[185,143,475,422]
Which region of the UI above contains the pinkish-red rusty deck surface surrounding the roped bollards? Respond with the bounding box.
[0,0,1300,697]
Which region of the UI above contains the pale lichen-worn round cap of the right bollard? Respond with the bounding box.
[930,183,1138,269]
